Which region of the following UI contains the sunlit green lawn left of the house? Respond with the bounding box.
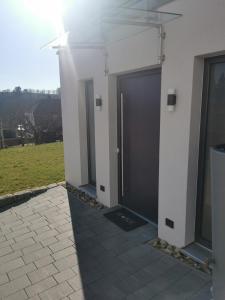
[0,142,64,195]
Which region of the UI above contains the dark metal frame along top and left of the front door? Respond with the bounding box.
[117,67,162,213]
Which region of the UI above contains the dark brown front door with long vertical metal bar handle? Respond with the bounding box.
[118,69,161,223]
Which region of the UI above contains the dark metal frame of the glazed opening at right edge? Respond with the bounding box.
[195,56,225,249]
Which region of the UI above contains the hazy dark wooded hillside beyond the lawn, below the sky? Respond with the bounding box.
[0,92,62,144]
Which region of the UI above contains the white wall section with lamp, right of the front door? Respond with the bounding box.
[159,0,225,247]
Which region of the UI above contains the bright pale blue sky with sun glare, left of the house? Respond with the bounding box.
[0,0,60,90]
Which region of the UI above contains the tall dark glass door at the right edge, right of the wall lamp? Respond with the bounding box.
[196,57,225,247]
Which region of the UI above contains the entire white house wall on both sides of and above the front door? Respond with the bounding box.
[60,0,225,247]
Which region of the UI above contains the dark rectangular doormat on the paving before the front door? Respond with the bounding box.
[104,208,148,231]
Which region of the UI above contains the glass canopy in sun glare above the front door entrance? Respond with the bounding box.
[66,0,181,45]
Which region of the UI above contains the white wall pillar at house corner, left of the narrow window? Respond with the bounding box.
[59,50,83,186]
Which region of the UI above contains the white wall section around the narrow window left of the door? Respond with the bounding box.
[59,49,111,206]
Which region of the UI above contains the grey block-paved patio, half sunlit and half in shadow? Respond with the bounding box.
[0,187,210,300]
